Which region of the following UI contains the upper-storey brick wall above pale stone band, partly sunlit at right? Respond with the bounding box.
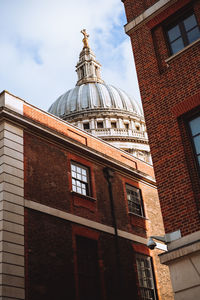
[24,132,163,237]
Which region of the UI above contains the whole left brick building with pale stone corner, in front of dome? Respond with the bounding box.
[0,91,173,300]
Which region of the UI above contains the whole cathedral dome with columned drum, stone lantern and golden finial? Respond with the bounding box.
[48,30,151,163]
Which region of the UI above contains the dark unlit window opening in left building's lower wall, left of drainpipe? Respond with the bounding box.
[76,236,101,300]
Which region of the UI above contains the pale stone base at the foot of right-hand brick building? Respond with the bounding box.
[160,231,200,300]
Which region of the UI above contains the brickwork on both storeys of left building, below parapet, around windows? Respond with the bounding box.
[24,132,173,300]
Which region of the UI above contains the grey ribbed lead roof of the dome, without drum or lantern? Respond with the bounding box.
[49,82,142,118]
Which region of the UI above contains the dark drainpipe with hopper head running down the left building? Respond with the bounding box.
[103,167,123,299]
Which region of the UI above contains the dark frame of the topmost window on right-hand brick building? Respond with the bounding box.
[163,6,200,56]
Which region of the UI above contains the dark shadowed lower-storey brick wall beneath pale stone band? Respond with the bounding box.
[25,210,141,300]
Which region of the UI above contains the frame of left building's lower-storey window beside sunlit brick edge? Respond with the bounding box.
[135,253,158,300]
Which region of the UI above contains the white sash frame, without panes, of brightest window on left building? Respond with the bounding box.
[70,161,91,197]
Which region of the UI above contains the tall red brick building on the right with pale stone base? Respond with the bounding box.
[123,0,200,300]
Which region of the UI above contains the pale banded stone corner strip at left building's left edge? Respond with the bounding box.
[0,122,25,300]
